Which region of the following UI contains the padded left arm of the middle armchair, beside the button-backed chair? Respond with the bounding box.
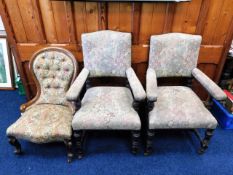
[66,68,89,101]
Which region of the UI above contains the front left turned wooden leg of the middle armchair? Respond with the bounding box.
[74,131,84,159]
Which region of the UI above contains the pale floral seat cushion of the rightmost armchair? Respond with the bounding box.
[149,86,217,129]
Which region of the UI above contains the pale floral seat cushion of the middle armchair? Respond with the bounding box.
[72,86,141,130]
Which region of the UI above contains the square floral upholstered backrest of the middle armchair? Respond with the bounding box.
[82,30,131,77]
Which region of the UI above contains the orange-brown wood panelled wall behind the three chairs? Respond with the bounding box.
[0,0,233,98]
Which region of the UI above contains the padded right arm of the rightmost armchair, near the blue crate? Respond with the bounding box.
[192,68,227,100]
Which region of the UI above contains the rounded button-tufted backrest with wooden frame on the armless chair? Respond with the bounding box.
[30,47,78,106]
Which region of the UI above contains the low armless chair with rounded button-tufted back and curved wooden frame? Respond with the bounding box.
[6,47,77,162]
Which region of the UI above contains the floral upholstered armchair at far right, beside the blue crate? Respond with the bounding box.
[145,33,226,155]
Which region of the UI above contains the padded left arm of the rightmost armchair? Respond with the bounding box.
[146,68,158,102]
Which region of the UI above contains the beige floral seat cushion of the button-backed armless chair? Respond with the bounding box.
[6,104,73,143]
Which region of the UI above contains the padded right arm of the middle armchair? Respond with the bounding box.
[126,67,146,101]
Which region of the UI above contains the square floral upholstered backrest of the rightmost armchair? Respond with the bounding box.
[149,33,202,77]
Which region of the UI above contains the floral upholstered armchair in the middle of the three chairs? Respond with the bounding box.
[66,30,146,158]
